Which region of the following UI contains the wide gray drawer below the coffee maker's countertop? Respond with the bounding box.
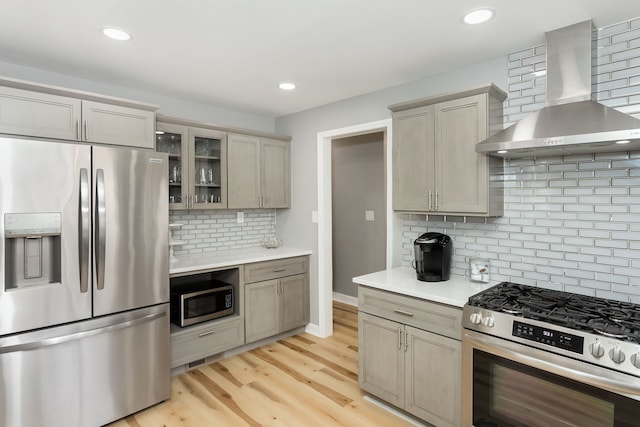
[358,286,462,340]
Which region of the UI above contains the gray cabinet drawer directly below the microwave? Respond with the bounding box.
[171,318,244,368]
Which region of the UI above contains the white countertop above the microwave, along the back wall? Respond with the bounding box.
[169,247,311,274]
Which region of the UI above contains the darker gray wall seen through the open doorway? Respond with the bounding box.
[331,132,387,297]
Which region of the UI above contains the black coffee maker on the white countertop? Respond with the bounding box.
[413,233,453,282]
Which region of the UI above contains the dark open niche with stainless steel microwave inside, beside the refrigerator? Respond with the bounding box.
[171,280,234,327]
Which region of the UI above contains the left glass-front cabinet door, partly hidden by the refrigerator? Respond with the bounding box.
[156,123,189,209]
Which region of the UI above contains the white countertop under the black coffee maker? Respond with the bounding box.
[353,267,498,307]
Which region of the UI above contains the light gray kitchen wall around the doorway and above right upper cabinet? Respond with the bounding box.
[276,56,507,324]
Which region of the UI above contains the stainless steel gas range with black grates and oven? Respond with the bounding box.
[462,284,640,427]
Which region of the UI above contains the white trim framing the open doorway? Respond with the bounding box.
[314,119,400,337]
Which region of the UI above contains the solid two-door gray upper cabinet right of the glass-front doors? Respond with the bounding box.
[227,134,291,209]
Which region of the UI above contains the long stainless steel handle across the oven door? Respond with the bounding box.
[463,331,640,400]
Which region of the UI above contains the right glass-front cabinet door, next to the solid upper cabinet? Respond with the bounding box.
[189,128,227,209]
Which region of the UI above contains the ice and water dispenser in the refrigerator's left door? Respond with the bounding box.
[4,212,62,290]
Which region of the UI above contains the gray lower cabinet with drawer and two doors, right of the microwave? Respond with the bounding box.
[244,257,309,343]
